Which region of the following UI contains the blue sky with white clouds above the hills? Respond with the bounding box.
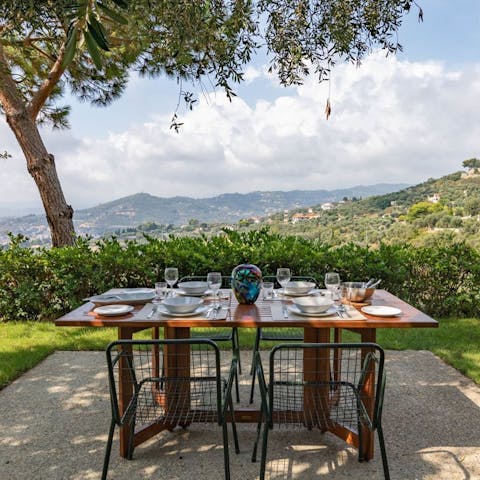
[0,0,480,215]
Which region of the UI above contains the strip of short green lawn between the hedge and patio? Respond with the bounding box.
[0,318,480,388]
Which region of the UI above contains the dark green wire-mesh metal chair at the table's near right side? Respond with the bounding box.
[252,343,390,480]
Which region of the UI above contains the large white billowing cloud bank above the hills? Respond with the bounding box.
[0,54,480,215]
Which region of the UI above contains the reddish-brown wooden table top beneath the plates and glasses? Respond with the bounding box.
[55,290,438,329]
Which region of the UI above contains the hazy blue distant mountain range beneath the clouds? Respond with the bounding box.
[0,183,407,243]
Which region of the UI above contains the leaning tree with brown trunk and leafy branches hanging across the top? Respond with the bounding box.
[0,0,423,246]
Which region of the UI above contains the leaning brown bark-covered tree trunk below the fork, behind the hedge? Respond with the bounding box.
[6,109,75,247]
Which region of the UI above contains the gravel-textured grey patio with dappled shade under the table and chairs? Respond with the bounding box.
[0,351,480,480]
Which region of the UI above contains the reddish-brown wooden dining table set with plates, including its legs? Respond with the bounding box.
[55,289,438,460]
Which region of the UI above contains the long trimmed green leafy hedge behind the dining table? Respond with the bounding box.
[0,229,480,320]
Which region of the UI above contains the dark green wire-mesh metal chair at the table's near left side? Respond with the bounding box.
[102,339,239,480]
